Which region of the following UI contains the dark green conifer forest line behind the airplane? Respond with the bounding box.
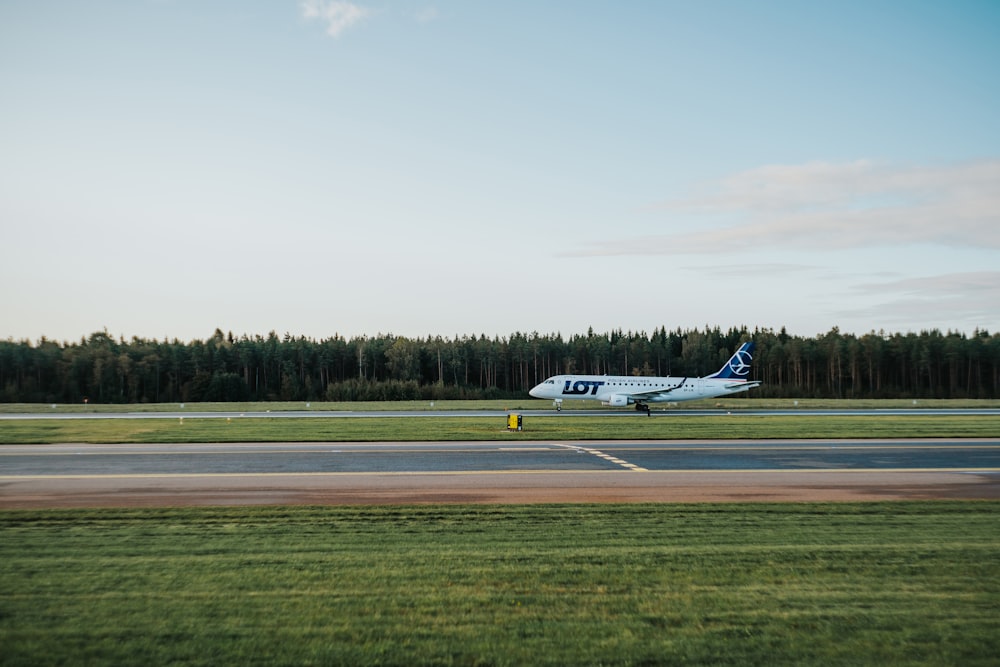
[0,327,1000,403]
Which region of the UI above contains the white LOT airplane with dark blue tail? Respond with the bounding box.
[528,342,760,414]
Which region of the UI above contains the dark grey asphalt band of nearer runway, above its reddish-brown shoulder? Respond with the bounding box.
[0,440,1000,477]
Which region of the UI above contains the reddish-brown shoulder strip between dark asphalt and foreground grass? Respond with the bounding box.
[0,471,1000,509]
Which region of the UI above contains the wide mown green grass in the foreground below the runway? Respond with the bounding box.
[0,502,1000,665]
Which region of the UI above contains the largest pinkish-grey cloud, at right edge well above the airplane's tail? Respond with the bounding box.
[568,160,1000,256]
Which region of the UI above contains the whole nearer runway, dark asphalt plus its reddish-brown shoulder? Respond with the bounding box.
[0,439,1000,508]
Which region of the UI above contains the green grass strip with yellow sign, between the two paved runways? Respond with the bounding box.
[0,413,1000,444]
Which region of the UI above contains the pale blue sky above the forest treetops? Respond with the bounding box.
[0,0,1000,342]
